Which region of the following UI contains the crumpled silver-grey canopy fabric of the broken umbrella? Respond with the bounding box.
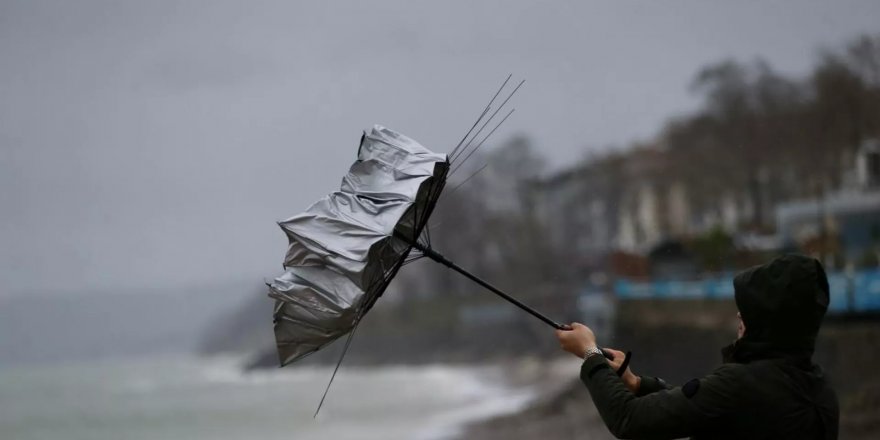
[269,125,449,366]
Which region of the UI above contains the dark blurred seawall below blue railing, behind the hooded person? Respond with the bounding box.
[613,299,880,392]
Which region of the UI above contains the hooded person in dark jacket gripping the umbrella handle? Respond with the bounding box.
[557,255,839,440]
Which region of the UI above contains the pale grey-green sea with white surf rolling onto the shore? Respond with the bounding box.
[0,355,536,440]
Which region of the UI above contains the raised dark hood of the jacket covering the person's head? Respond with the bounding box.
[733,254,829,362]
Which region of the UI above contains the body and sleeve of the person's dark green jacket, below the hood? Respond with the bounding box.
[581,356,838,440]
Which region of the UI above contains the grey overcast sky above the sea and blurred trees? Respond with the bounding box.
[0,0,880,296]
